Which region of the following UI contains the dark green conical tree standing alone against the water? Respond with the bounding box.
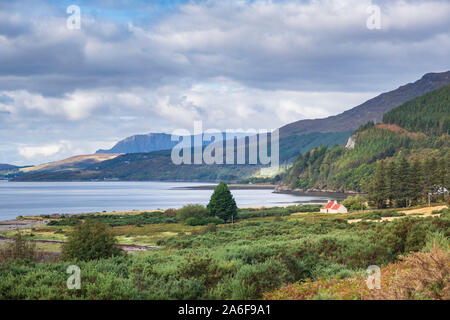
[207,182,237,221]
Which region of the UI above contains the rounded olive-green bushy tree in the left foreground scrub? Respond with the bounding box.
[63,219,124,261]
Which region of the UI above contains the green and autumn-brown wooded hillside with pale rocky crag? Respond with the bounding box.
[278,86,450,192]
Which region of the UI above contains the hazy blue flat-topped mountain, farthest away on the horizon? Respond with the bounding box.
[96,133,253,153]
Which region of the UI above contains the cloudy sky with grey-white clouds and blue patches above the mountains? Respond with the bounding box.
[0,0,450,165]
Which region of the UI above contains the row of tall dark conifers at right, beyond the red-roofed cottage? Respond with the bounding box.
[369,156,450,209]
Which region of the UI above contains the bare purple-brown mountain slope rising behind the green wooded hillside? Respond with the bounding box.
[280,71,450,137]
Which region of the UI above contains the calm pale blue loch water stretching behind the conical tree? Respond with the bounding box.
[0,180,327,221]
